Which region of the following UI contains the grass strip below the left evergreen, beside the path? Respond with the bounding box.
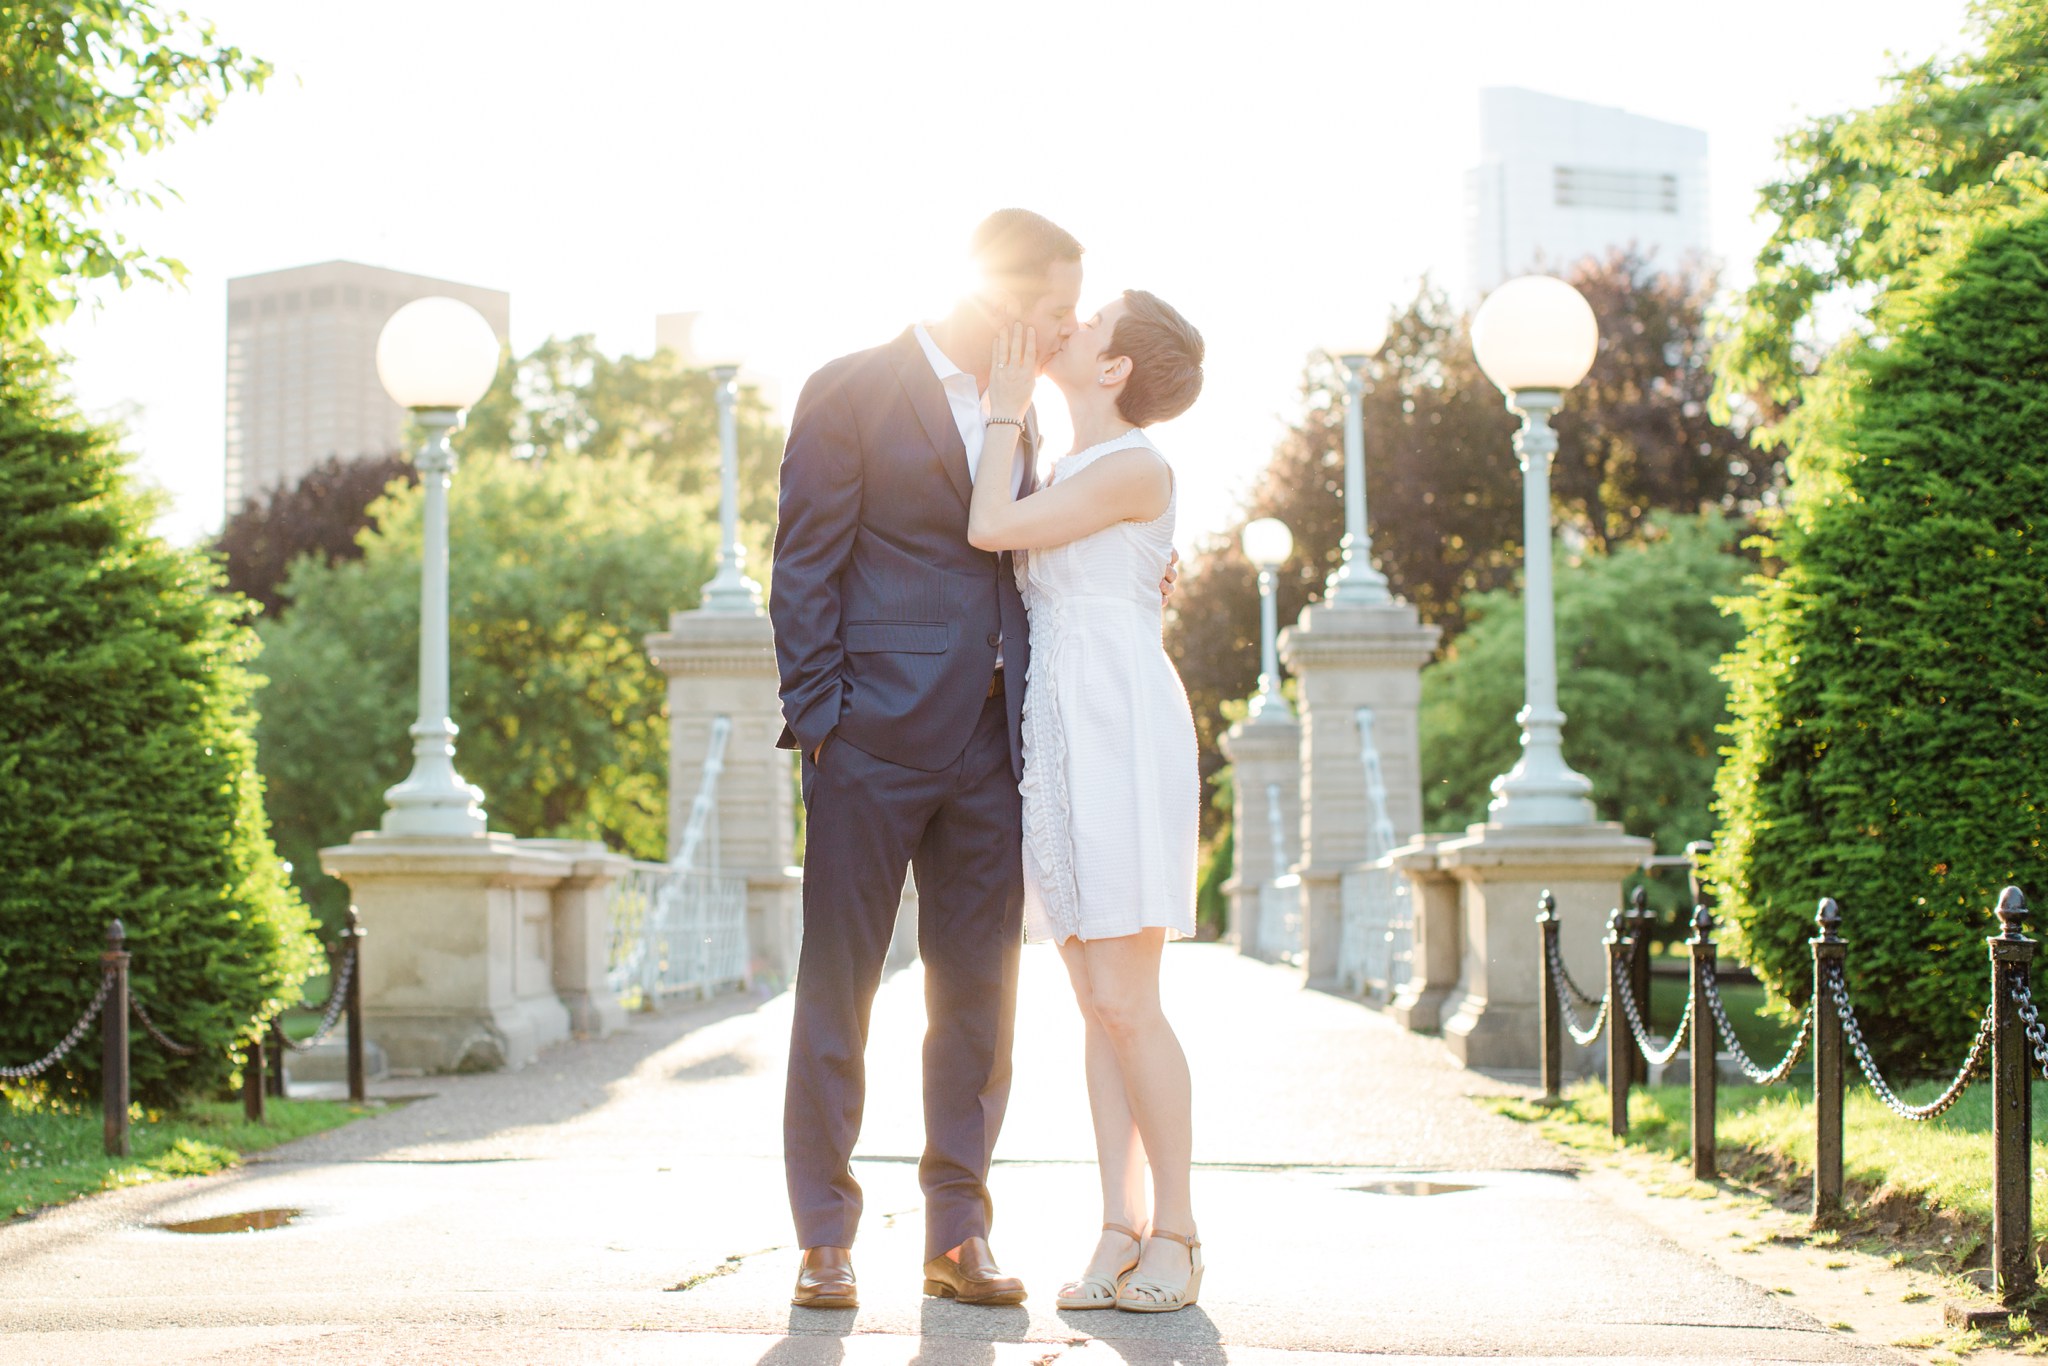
[0,1087,383,1219]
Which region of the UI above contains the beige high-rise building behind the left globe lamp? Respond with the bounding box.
[227,260,512,516]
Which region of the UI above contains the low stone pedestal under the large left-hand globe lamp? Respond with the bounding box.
[319,831,623,1071]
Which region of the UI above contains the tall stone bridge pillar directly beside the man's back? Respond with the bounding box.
[647,610,801,985]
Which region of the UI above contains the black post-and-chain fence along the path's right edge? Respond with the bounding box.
[1536,876,2048,1307]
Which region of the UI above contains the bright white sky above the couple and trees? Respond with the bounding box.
[55,0,1966,545]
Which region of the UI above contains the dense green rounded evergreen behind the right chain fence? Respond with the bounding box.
[1714,202,2048,1073]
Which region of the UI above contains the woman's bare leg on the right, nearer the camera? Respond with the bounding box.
[1081,930,1194,1284]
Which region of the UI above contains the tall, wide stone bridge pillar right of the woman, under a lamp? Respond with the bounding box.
[1280,602,1440,983]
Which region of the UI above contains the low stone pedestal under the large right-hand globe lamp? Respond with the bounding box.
[1434,821,1651,1071]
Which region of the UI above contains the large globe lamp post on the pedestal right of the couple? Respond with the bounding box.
[1473,274,1599,825]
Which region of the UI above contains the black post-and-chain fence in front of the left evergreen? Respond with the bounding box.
[0,907,367,1157]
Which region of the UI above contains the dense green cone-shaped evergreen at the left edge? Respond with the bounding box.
[0,389,313,1102]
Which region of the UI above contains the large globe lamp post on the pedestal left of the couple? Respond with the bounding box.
[377,297,498,836]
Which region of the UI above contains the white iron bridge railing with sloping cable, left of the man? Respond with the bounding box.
[608,717,750,1010]
